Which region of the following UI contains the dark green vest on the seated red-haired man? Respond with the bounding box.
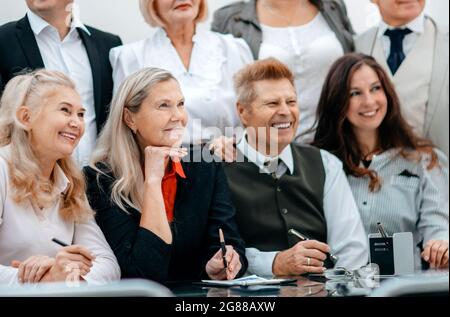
[225,144,327,251]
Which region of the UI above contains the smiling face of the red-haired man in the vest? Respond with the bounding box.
[238,79,299,154]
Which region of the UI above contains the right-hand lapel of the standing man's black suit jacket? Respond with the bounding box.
[77,28,102,118]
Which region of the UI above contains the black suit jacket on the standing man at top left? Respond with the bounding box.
[0,16,122,132]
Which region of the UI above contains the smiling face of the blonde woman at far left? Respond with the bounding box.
[25,87,85,161]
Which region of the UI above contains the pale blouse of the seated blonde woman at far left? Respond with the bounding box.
[0,146,120,285]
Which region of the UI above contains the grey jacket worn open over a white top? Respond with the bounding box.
[211,0,354,59]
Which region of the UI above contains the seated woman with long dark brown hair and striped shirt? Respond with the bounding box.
[314,54,449,268]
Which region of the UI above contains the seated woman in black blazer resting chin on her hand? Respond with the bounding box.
[85,68,247,282]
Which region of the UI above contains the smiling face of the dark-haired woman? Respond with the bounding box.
[347,65,388,136]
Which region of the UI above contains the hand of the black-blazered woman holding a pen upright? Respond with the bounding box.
[206,229,242,280]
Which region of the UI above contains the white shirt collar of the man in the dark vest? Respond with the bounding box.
[236,131,294,175]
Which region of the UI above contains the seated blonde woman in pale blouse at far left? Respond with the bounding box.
[0,70,120,285]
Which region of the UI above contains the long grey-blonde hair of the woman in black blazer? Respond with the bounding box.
[90,68,176,212]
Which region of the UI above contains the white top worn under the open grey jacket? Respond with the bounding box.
[259,13,344,143]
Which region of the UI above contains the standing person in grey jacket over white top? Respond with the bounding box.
[212,0,354,143]
